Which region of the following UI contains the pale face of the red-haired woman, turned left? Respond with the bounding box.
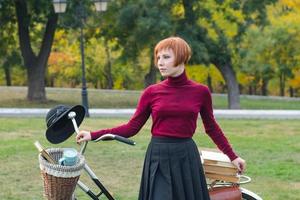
[157,49,184,77]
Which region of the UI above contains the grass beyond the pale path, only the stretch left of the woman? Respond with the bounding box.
[0,87,140,108]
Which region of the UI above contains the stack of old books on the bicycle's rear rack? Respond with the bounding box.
[200,150,240,183]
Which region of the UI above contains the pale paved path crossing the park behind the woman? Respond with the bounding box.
[0,108,300,119]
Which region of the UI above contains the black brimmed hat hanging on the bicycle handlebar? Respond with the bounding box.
[46,105,85,144]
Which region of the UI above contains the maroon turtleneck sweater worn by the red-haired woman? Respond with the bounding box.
[91,72,237,160]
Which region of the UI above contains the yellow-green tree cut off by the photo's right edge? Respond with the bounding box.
[269,0,300,96]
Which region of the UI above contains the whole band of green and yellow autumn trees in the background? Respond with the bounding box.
[0,0,300,108]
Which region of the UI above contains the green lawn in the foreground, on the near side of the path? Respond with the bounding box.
[0,118,300,200]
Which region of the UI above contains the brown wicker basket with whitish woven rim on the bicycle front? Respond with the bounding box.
[39,148,85,200]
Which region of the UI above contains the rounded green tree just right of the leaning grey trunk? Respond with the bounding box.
[237,26,275,96]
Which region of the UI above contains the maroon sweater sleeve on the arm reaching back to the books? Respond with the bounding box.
[200,87,237,161]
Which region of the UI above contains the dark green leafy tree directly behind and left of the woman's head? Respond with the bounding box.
[101,0,174,87]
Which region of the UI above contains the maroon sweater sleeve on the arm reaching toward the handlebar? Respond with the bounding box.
[91,87,151,140]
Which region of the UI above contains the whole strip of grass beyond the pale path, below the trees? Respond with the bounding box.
[0,87,300,110]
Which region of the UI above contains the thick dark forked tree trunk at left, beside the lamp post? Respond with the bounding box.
[15,0,58,101]
